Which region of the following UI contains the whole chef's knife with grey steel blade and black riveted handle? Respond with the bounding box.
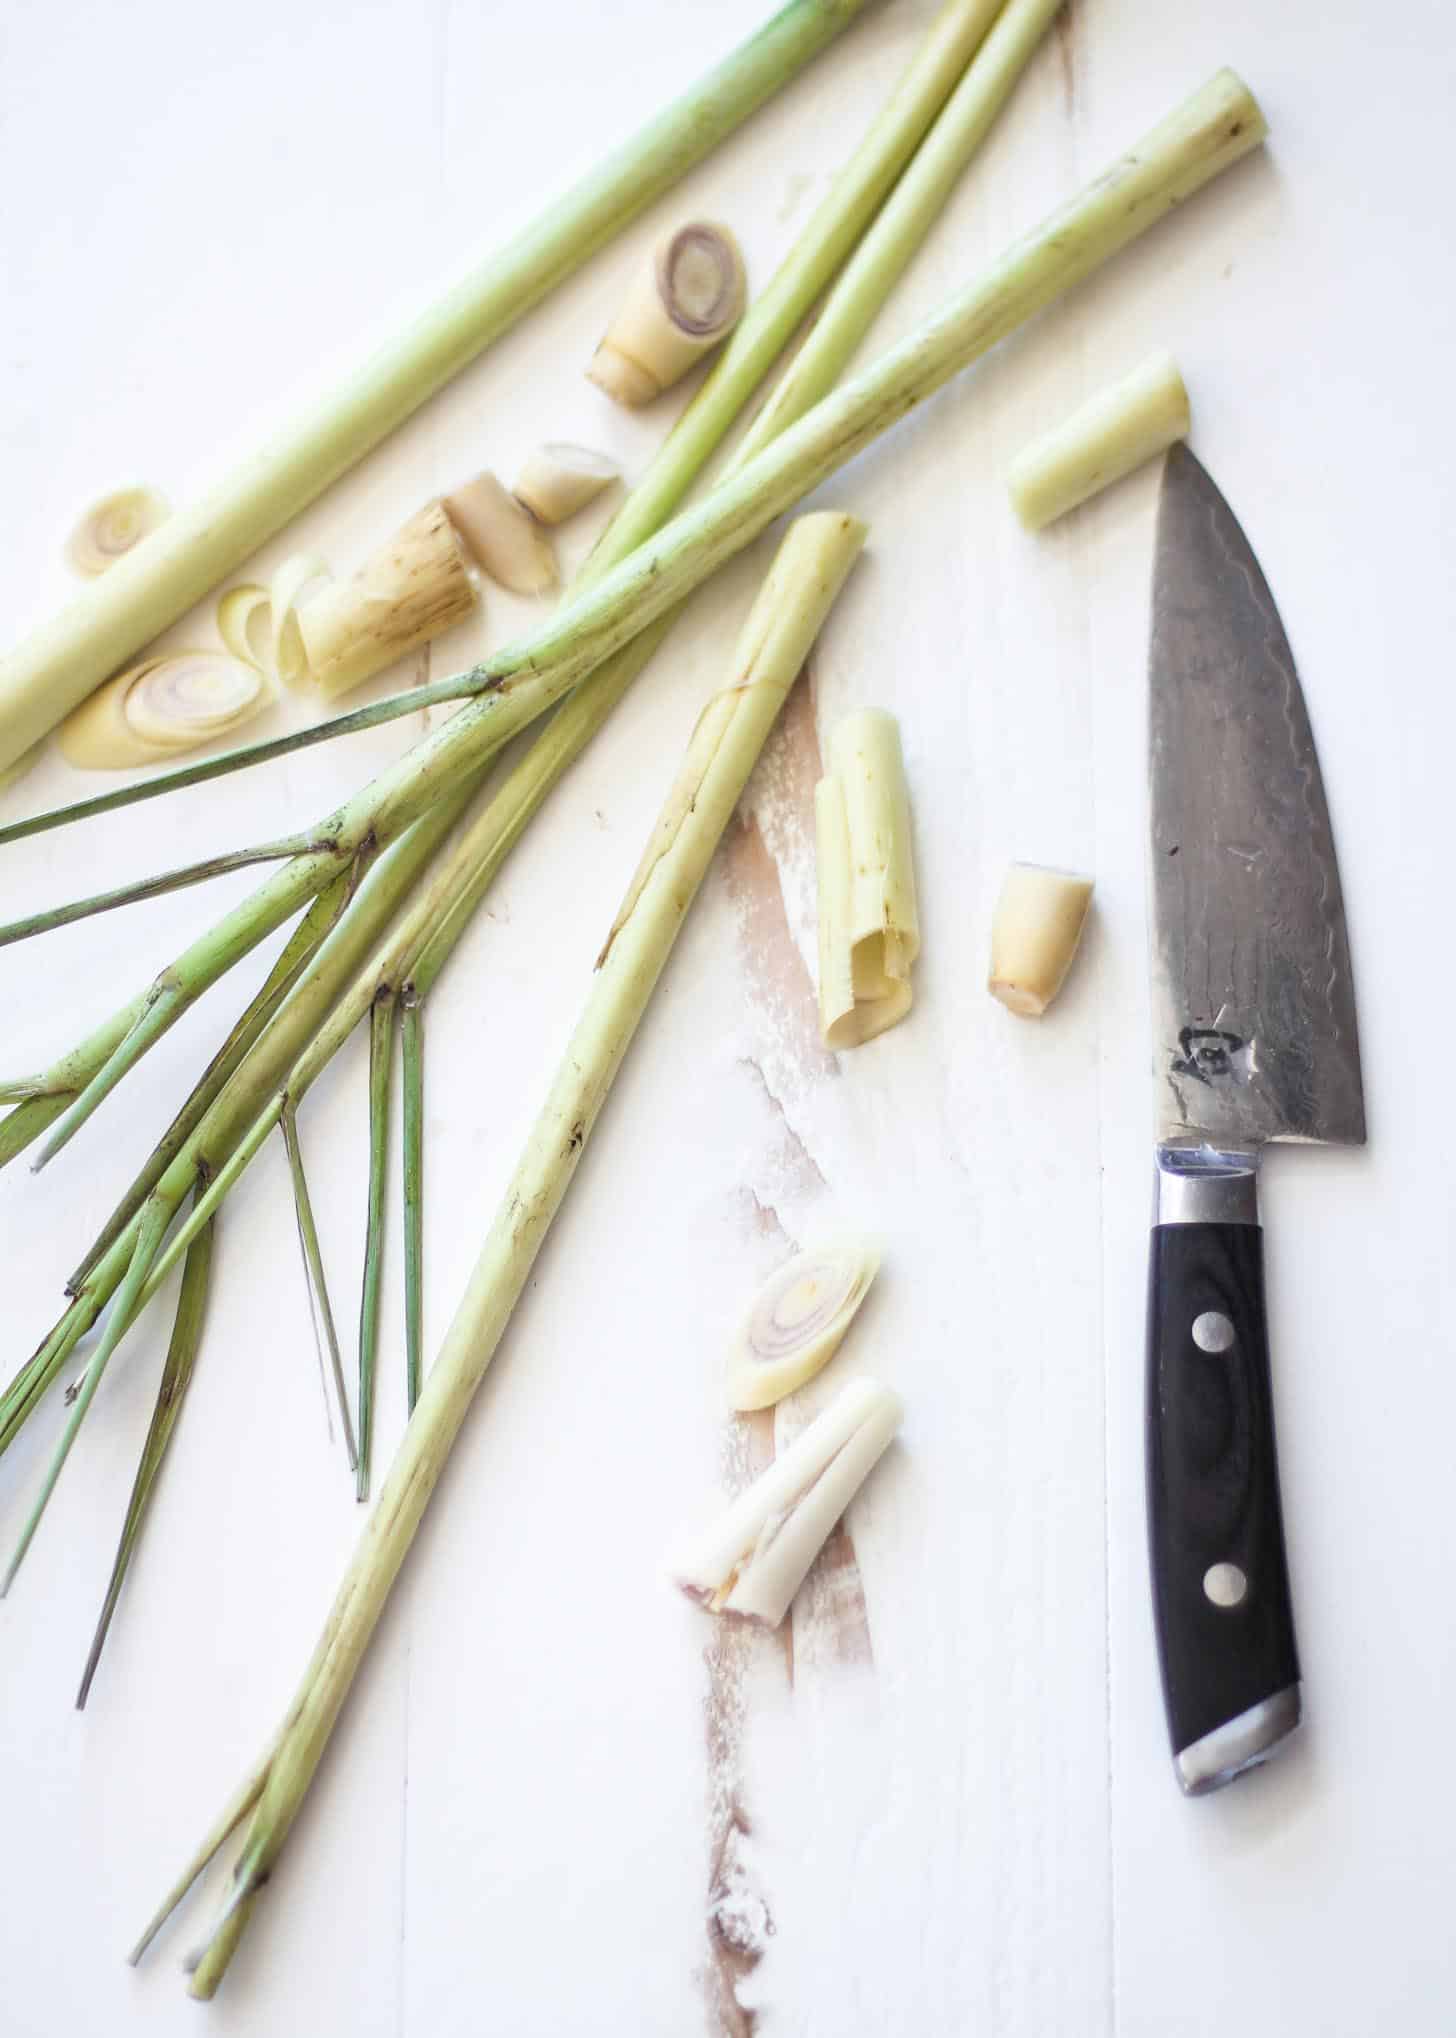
[1146,446,1364,1795]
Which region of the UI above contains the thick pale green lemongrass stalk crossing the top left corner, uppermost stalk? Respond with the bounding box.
[0,0,863,766]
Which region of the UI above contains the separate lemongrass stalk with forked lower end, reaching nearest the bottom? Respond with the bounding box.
[162,512,865,1997]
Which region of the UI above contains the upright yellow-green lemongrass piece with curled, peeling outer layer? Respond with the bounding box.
[814,707,920,1050]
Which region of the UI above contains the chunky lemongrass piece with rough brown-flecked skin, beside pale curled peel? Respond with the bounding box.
[293,501,479,699]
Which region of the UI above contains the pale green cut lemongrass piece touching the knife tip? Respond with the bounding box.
[1005,351,1191,530]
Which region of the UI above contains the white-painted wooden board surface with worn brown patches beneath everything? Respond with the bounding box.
[0,0,1456,2038]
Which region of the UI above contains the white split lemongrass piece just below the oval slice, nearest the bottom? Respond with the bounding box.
[671,1380,905,1628]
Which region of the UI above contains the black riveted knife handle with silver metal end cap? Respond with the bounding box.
[1148,1180,1299,1795]
